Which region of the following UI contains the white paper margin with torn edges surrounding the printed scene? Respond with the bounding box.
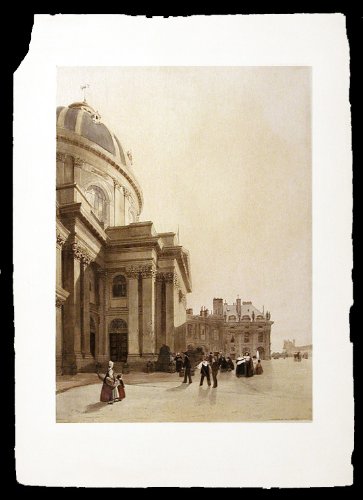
[14,14,353,487]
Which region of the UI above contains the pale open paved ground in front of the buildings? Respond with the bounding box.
[57,358,312,422]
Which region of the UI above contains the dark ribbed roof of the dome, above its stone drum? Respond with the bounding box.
[57,101,129,166]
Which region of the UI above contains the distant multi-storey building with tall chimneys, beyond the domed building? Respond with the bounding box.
[175,298,273,359]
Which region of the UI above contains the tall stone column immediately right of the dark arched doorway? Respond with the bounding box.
[126,267,139,359]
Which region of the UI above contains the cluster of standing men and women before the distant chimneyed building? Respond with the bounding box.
[175,352,263,388]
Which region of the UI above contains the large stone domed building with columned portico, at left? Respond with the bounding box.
[56,101,191,374]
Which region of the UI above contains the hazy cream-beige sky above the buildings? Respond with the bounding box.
[57,67,312,350]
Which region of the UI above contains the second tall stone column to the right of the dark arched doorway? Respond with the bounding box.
[141,265,156,356]
